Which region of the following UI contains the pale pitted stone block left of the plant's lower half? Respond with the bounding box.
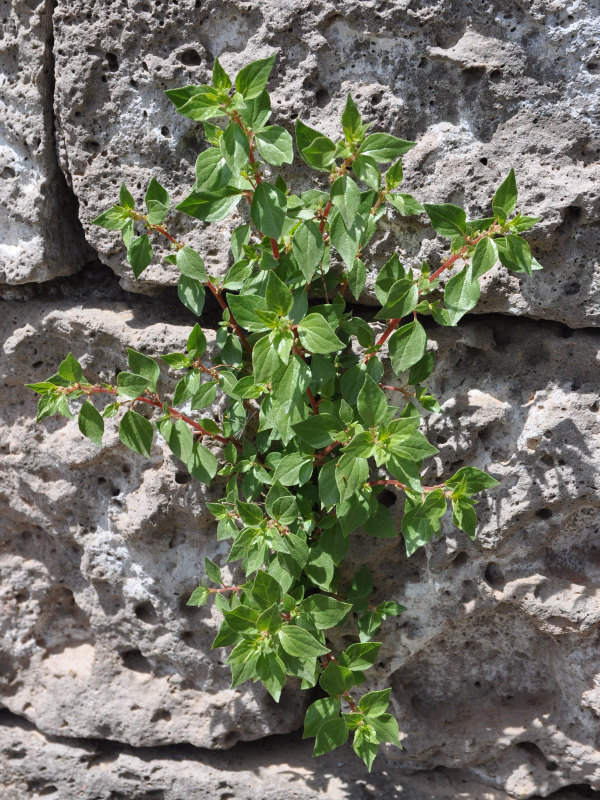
[0,301,308,748]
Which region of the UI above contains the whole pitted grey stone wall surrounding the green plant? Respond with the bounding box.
[0,0,600,800]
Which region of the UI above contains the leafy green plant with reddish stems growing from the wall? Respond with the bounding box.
[30,56,540,769]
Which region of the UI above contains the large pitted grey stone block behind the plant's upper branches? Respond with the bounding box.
[55,0,600,327]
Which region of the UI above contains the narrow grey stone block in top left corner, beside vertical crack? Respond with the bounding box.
[0,0,91,285]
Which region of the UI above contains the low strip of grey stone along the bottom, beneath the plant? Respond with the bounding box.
[0,710,592,800]
